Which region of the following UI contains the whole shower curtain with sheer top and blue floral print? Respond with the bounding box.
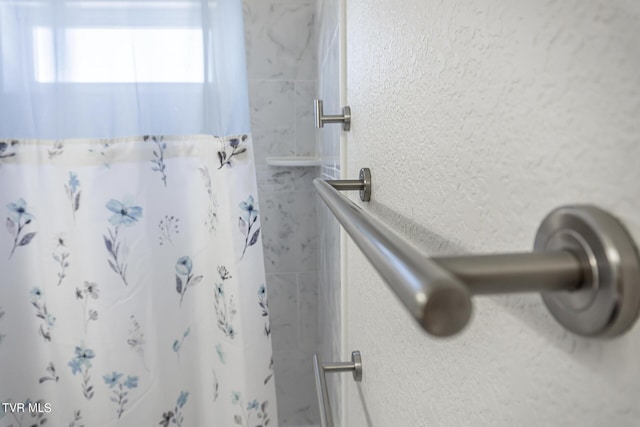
[0,0,277,427]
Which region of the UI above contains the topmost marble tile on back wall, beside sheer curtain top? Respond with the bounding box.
[243,0,316,80]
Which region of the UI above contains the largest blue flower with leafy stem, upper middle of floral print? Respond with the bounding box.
[102,199,142,286]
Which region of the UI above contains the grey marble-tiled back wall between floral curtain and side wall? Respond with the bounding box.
[243,0,319,427]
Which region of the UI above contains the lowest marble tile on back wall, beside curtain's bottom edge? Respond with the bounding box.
[274,353,320,426]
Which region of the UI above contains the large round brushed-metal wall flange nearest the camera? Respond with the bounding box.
[534,205,640,337]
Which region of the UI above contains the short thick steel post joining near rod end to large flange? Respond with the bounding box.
[431,251,589,295]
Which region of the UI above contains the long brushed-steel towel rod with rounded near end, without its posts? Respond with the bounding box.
[314,179,471,336]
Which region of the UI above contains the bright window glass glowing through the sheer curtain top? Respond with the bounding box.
[33,27,204,83]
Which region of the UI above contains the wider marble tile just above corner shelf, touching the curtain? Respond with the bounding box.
[249,80,296,164]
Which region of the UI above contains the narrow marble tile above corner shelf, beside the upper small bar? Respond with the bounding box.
[295,81,316,156]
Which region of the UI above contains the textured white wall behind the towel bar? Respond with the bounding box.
[343,0,640,427]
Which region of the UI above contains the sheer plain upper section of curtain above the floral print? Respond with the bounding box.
[0,0,249,139]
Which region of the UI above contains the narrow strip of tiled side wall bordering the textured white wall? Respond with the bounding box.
[316,0,348,426]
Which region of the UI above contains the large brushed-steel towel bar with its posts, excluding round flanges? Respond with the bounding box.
[314,179,591,336]
